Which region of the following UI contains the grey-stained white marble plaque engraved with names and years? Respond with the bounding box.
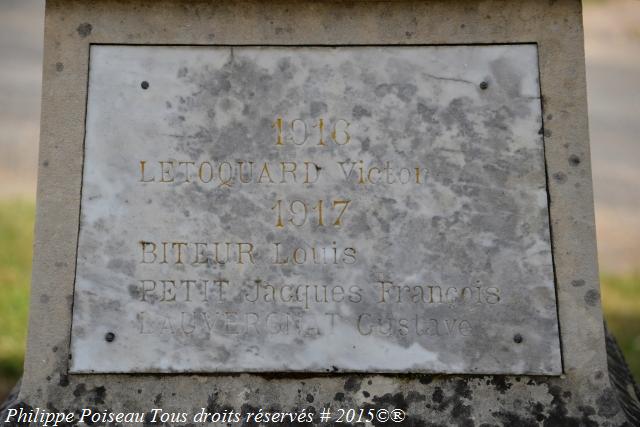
[71,45,562,375]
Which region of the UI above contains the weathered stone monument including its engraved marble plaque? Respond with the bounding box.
[3,0,631,426]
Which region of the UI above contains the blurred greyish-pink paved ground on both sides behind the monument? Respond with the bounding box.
[0,0,640,272]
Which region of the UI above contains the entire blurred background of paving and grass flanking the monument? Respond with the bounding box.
[0,0,640,402]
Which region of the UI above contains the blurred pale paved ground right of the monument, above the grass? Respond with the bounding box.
[585,0,640,272]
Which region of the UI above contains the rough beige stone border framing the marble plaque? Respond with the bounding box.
[12,0,630,426]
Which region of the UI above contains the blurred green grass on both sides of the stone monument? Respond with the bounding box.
[0,199,640,402]
